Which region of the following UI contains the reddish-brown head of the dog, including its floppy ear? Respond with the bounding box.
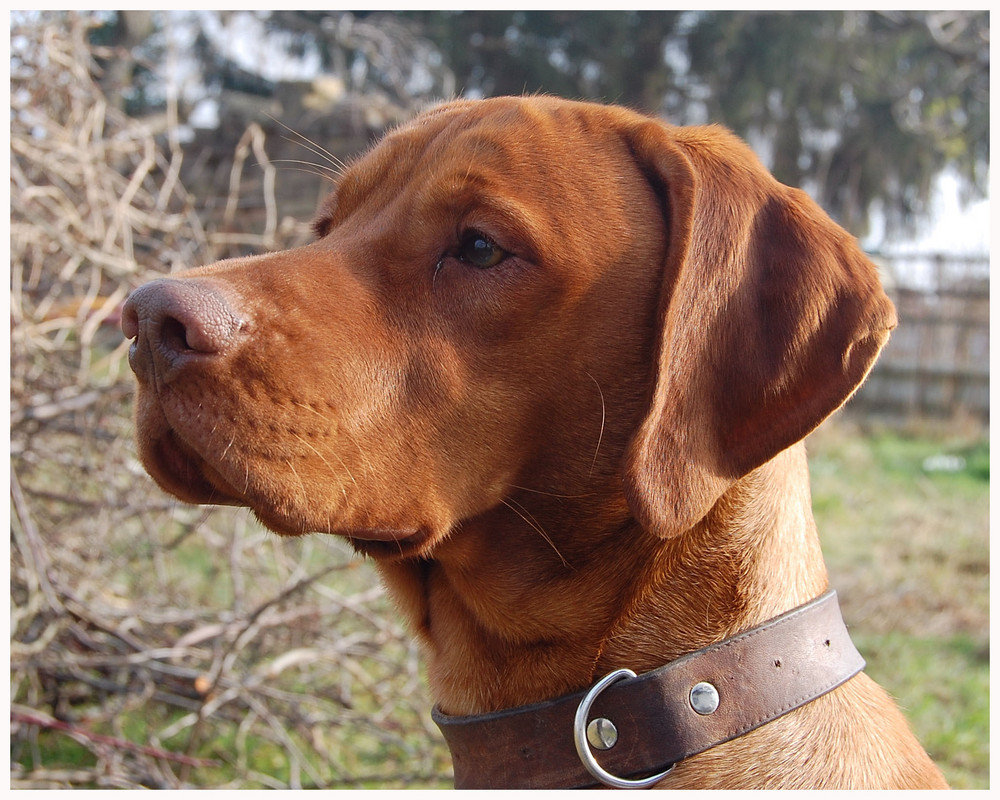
[123,98,894,556]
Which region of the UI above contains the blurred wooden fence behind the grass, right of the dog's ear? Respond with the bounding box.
[850,255,990,424]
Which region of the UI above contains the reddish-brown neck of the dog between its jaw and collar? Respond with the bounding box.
[379,445,827,714]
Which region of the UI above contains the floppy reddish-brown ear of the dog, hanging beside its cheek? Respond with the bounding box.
[624,122,896,536]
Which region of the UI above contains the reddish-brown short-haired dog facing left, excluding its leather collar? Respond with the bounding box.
[123,98,944,788]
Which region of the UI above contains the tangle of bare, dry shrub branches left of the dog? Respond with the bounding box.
[11,13,449,788]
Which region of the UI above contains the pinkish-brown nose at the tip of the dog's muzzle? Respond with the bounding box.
[122,278,247,381]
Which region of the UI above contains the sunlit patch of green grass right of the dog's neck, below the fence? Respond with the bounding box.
[809,424,990,789]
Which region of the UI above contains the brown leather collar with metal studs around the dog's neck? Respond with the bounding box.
[433,591,865,789]
